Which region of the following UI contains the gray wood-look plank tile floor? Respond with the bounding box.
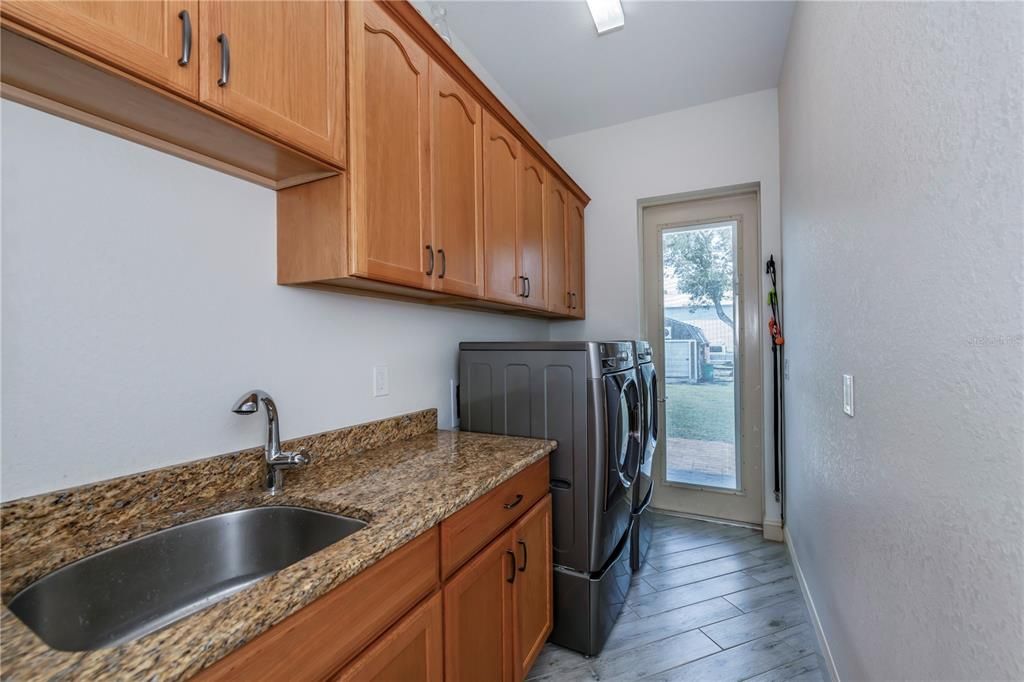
[528,514,826,682]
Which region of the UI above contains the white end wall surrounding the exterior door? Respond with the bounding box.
[548,89,781,520]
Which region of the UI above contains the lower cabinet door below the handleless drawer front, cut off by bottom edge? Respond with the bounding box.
[334,593,443,682]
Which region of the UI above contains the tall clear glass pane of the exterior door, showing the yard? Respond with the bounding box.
[662,220,740,491]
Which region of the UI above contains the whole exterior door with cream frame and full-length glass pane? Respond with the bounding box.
[643,194,765,524]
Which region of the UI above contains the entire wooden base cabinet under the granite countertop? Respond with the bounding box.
[193,459,554,682]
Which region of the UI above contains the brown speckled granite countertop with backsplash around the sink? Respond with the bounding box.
[0,410,555,680]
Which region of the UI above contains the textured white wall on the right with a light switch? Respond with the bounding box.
[779,3,1024,680]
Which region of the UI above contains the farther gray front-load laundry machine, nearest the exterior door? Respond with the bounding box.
[618,341,658,570]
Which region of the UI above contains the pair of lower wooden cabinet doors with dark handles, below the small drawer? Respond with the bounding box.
[444,494,553,682]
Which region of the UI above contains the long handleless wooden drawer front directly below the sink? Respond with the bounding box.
[195,527,439,682]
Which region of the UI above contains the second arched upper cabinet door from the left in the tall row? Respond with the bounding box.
[430,62,483,296]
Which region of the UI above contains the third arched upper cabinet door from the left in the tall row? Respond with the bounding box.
[483,114,524,304]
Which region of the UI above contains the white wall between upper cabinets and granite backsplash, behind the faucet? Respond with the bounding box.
[0,101,548,500]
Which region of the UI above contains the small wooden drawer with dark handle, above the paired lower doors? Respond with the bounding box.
[441,458,550,578]
